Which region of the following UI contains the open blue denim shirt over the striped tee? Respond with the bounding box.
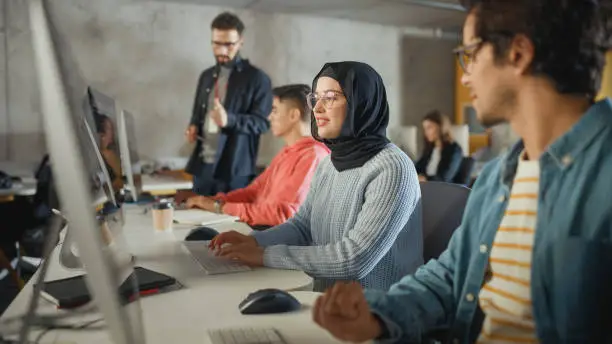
[366,99,612,344]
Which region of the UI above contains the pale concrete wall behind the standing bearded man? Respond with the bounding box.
[0,0,402,167]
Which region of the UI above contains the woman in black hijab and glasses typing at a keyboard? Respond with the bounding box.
[211,62,423,291]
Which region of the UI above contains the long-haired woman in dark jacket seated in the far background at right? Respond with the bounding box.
[416,110,463,183]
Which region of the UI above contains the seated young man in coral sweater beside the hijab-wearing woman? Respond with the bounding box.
[187,84,329,229]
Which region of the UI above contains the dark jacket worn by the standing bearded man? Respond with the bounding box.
[185,57,272,181]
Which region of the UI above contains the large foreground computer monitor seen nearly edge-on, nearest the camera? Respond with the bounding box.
[29,0,144,344]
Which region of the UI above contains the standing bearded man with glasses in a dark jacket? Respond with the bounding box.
[185,12,272,196]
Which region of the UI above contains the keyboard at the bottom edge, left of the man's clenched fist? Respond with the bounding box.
[208,328,287,344]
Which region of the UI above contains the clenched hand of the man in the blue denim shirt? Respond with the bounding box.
[312,282,382,343]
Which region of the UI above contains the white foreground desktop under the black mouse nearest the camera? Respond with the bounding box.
[19,292,340,344]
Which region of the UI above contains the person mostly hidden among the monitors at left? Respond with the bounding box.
[96,113,123,192]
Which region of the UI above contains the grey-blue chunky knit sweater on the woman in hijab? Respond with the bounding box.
[252,144,423,291]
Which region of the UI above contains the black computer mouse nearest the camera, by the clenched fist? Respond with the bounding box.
[238,289,302,314]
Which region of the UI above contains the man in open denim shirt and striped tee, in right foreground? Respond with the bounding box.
[313,0,612,344]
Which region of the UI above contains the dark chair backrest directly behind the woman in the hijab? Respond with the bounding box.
[421,182,470,262]
